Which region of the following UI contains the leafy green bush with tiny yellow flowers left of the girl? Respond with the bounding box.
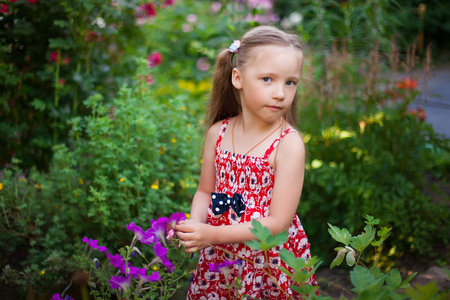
[0,78,202,296]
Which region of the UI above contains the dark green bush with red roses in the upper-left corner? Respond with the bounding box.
[0,0,146,169]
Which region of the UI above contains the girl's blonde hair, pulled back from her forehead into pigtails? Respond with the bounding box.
[206,26,303,128]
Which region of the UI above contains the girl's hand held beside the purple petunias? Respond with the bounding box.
[174,220,212,253]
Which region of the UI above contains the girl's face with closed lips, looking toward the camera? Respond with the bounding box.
[232,46,303,123]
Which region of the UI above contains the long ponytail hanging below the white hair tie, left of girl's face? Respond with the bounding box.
[206,49,241,128]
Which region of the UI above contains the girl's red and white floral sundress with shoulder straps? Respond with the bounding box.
[187,119,317,300]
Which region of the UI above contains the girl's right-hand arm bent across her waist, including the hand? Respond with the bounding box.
[175,134,305,252]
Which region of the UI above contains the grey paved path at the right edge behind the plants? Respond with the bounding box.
[419,66,450,138]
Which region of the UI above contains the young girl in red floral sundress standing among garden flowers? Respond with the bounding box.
[175,26,317,299]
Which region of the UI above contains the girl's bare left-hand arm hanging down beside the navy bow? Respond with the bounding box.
[189,123,221,223]
